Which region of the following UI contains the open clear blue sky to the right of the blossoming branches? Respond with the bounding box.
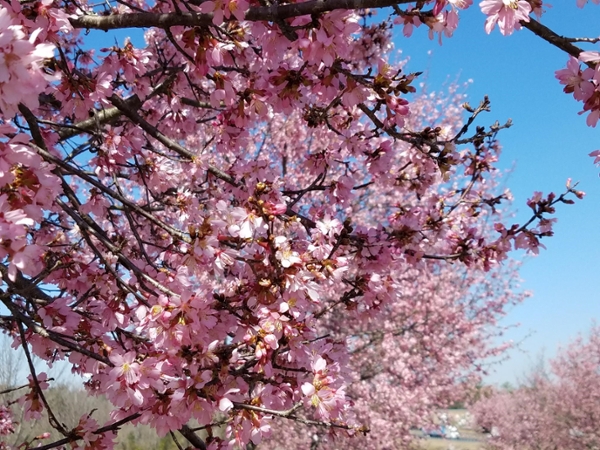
[394,0,600,383]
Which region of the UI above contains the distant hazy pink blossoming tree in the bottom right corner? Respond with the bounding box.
[473,325,600,449]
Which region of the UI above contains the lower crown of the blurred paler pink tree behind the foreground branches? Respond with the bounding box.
[259,260,518,449]
